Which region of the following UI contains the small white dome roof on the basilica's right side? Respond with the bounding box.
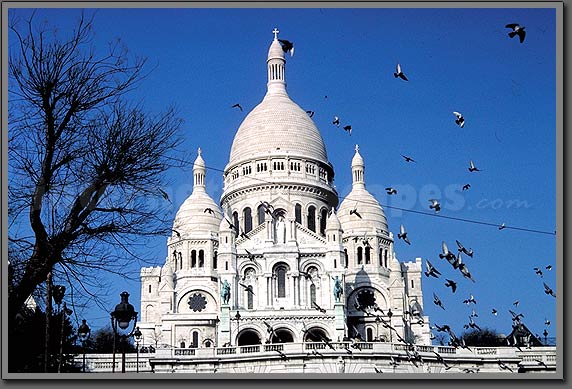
[338,186,388,234]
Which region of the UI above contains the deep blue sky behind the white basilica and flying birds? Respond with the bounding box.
[6,8,558,342]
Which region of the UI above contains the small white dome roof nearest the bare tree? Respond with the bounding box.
[173,190,222,237]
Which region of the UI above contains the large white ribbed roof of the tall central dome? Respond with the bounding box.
[229,94,328,166]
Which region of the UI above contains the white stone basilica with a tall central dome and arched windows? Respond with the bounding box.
[138,30,431,355]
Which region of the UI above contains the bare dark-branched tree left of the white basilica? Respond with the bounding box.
[8,14,185,317]
